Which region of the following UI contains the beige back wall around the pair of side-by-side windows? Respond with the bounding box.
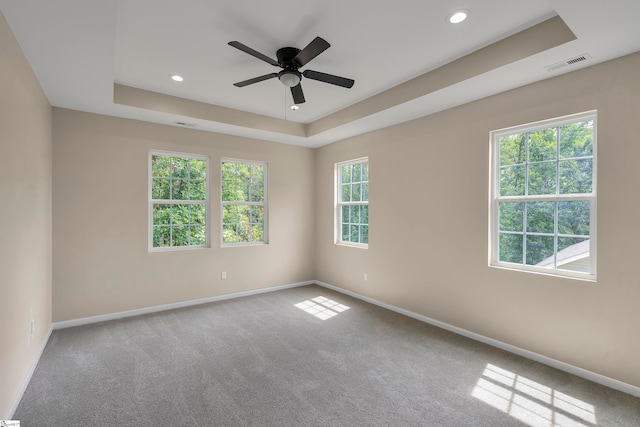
[53,108,315,321]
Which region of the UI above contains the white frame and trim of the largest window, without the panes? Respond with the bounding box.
[489,110,598,282]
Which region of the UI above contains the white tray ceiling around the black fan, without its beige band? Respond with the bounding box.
[0,0,640,147]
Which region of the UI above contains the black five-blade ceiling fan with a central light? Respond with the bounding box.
[229,37,355,104]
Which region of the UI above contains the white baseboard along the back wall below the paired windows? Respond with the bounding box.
[53,280,316,330]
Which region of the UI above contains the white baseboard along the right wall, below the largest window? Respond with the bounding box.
[314,280,640,397]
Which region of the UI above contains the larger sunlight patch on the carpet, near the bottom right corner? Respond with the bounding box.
[471,363,598,427]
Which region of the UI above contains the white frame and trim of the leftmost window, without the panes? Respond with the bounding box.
[147,150,211,252]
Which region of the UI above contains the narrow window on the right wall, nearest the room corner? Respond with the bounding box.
[336,158,369,247]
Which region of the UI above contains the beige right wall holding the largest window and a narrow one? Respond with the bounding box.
[316,54,640,386]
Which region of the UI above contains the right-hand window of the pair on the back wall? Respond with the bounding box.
[221,159,267,246]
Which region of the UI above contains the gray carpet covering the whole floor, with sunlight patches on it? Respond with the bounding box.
[14,286,640,427]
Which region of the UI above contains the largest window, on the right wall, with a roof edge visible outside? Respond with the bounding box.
[490,112,596,280]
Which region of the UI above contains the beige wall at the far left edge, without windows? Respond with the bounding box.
[0,13,51,419]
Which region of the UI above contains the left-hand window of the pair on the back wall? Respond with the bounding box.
[149,152,209,250]
